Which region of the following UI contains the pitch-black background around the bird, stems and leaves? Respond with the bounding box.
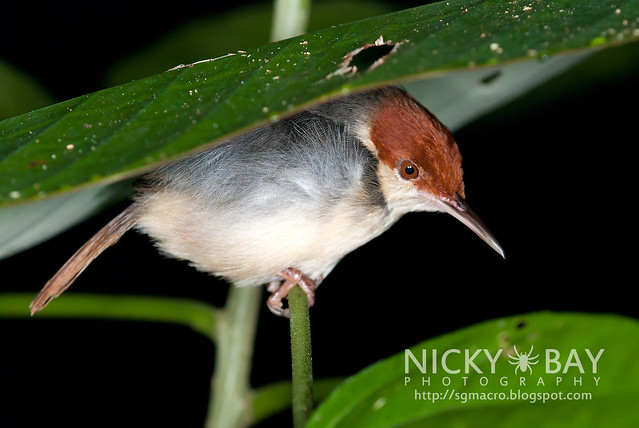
[0,0,639,427]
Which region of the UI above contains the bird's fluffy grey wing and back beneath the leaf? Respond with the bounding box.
[144,112,381,214]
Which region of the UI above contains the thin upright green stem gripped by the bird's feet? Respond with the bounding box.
[288,287,313,428]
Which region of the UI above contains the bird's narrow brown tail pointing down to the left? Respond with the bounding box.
[29,204,140,315]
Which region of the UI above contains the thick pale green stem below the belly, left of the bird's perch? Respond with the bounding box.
[205,287,262,428]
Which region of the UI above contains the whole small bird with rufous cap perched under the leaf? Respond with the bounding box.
[31,86,504,316]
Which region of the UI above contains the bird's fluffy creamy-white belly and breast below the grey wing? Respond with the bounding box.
[138,181,392,286]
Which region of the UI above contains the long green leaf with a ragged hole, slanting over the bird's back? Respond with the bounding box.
[0,0,639,205]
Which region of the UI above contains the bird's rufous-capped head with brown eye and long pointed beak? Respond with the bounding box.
[369,88,504,256]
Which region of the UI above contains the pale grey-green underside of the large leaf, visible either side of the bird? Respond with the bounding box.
[0,51,592,258]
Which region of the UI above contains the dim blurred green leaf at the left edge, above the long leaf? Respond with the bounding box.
[0,60,54,119]
